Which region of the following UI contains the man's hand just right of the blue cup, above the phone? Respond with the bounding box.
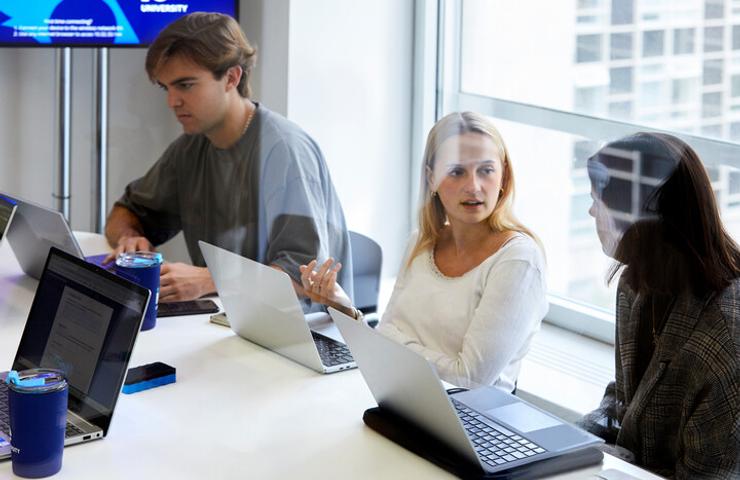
[159,263,216,302]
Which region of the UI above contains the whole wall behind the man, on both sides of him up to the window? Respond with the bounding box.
[0,0,413,275]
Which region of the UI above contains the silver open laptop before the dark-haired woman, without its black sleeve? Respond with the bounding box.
[329,308,603,473]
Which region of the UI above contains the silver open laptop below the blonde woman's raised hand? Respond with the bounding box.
[198,241,356,373]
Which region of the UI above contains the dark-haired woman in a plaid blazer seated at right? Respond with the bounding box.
[581,133,740,479]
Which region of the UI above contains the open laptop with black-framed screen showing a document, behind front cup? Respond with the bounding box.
[0,248,150,459]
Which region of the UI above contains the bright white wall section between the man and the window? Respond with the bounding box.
[288,0,416,276]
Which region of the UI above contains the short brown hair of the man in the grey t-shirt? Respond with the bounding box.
[146,12,257,98]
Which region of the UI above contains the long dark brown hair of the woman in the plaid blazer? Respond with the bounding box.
[589,133,740,295]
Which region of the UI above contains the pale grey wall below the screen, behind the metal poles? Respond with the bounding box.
[0,48,187,259]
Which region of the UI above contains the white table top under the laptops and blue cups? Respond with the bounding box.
[0,237,658,480]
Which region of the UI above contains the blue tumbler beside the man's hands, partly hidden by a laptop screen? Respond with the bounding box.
[116,252,162,331]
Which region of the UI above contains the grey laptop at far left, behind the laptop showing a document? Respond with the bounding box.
[0,194,107,279]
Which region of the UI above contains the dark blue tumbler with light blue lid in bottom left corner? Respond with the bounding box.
[6,368,69,478]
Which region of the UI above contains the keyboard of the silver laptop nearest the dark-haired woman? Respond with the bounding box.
[450,398,546,467]
